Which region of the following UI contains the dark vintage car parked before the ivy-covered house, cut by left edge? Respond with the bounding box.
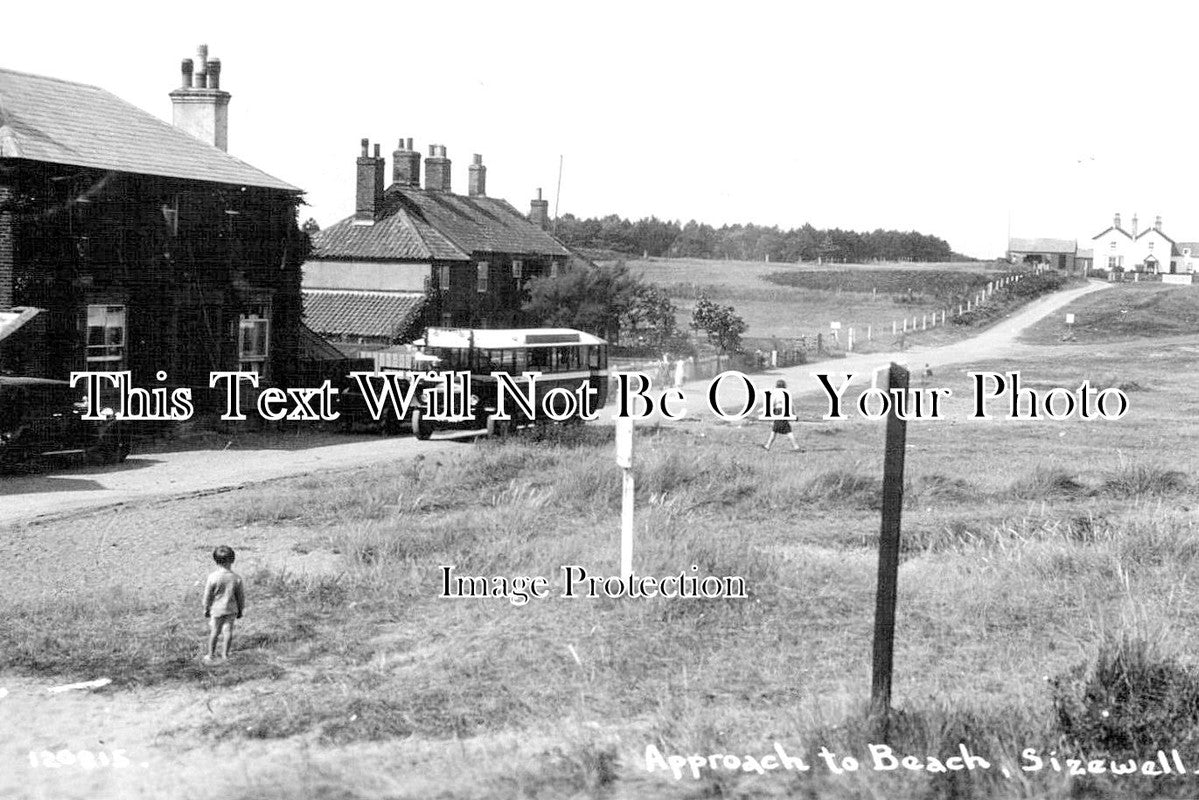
[0,375,129,468]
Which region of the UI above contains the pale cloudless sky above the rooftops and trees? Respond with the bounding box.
[0,0,1199,258]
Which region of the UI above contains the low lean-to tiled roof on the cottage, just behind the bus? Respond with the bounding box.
[303,289,424,338]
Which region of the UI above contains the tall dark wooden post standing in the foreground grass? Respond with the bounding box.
[870,363,910,736]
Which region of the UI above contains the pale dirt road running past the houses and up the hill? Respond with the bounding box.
[0,282,1108,528]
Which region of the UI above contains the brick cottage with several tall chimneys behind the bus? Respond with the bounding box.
[303,139,574,345]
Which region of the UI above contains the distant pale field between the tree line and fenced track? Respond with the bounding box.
[628,259,1021,347]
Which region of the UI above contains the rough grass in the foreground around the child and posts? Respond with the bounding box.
[7,297,1199,800]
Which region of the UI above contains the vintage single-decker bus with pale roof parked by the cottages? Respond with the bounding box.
[411,327,608,439]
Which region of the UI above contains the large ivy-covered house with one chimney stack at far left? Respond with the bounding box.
[0,47,306,398]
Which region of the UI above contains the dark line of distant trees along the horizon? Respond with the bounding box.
[555,213,974,263]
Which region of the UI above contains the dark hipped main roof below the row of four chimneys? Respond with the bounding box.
[313,186,570,261]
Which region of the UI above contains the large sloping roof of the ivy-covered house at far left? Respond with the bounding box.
[0,70,300,192]
